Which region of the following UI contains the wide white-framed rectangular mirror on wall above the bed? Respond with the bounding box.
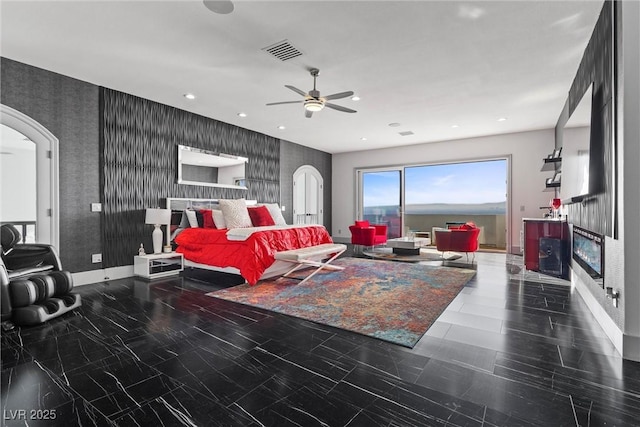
[178,145,249,190]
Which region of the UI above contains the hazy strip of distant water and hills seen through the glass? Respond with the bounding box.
[364,202,507,215]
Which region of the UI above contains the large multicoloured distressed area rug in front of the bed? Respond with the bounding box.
[207,258,475,348]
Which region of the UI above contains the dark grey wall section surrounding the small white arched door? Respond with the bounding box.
[280,141,332,230]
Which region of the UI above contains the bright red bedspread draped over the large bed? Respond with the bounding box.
[175,225,333,285]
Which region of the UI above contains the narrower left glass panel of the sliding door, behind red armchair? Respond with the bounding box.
[358,169,402,239]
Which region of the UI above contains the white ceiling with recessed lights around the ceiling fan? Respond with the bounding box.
[0,0,603,153]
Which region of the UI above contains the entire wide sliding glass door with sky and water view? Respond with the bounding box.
[357,159,508,250]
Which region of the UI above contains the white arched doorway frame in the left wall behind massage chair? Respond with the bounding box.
[0,104,60,248]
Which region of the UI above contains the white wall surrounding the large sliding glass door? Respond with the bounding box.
[331,129,555,250]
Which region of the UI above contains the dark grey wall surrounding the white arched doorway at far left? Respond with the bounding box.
[0,58,101,272]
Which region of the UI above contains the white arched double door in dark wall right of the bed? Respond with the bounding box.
[293,165,324,225]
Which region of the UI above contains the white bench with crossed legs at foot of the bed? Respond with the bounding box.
[274,243,347,284]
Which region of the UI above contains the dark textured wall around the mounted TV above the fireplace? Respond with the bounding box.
[556,1,617,237]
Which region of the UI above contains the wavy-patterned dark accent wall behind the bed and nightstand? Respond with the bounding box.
[102,89,280,267]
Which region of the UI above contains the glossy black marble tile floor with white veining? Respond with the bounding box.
[0,249,640,427]
